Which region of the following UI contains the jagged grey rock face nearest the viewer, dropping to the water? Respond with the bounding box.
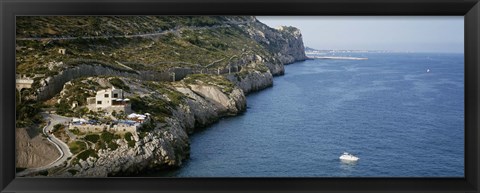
[65,126,189,177]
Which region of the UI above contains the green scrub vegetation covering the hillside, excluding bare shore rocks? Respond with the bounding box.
[16,16,308,175]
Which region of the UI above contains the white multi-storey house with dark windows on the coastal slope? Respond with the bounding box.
[87,87,131,113]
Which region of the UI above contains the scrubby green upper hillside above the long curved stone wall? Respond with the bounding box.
[16,16,282,77]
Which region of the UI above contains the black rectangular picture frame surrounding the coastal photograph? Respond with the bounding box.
[0,0,480,193]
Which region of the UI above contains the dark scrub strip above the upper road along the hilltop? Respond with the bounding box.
[16,16,231,38]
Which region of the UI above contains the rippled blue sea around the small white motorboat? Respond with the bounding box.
[158,53,464,177]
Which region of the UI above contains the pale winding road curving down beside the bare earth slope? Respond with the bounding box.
[17,113,72,176]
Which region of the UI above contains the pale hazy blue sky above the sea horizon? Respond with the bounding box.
[257,16,464,53]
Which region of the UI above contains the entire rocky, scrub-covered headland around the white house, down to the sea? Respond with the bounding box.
[16,16,306,176]
